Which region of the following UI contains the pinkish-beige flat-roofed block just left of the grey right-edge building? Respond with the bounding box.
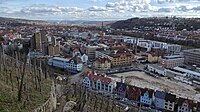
[160,55,184,68]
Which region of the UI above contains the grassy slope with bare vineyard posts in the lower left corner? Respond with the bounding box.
[0,64,51,112]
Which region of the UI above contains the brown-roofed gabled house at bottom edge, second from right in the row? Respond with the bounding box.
[177,98,194,112]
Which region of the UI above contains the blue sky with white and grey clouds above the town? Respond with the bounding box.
[0,0,200,21]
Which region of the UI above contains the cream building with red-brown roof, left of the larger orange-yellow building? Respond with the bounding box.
[95,58,111,70]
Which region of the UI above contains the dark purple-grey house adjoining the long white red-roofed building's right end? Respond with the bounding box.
[115,82,127,98]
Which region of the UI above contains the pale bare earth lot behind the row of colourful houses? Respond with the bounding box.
[109,71,200,101]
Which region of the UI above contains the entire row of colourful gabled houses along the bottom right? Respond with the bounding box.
[83,72,200,112]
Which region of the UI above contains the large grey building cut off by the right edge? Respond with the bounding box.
[183,49,200,67]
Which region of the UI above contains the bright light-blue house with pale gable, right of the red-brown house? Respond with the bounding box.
[140,88,154,106]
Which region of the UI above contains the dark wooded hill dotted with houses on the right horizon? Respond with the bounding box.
[111,17,200,30]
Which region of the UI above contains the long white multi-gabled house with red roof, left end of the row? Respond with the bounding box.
[83,72,116,93]
